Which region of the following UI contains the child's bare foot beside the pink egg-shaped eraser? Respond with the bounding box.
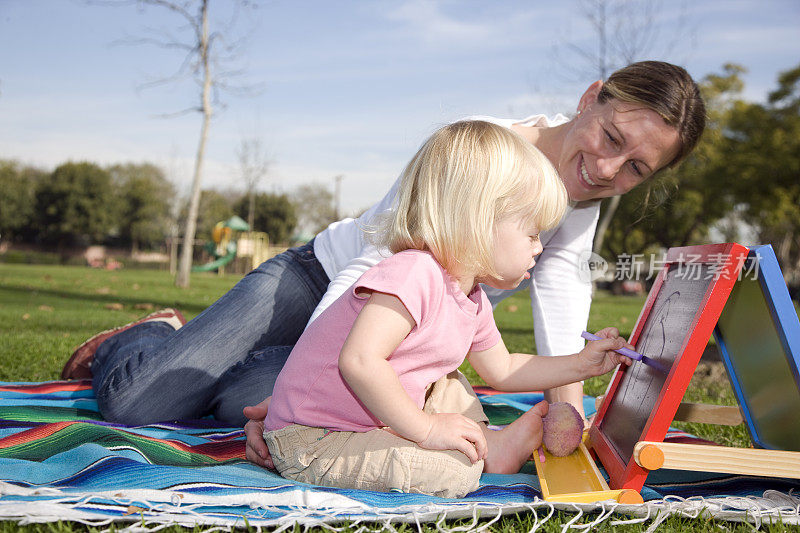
[481,402,549,474]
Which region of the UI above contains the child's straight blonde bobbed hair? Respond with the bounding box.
[377,120,568,276]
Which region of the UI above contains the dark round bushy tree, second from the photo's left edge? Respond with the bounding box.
[35,163,118,248]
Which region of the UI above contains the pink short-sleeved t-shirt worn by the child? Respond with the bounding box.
[264,250,500,431]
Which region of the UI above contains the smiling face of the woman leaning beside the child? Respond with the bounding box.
[554,82,680,202]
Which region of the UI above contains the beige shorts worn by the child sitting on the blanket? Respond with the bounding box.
[264,372,488,498]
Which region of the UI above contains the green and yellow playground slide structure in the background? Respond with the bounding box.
[192,215,269,274]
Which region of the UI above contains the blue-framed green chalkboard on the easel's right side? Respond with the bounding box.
[714,245,800,452]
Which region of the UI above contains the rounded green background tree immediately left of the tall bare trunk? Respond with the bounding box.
[108,163,175,252]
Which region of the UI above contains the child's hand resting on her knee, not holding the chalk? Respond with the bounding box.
[417,413,488,463]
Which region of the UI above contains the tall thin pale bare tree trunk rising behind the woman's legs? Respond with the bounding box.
[175,0,213,288]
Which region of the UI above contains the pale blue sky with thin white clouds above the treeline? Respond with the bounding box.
[0,0,800,211]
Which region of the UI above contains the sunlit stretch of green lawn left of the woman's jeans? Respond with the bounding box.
[0,264,238,381]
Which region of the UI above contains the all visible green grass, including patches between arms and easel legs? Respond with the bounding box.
[0,264,788,533]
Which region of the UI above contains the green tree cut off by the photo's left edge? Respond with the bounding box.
[0,161,45,240]
